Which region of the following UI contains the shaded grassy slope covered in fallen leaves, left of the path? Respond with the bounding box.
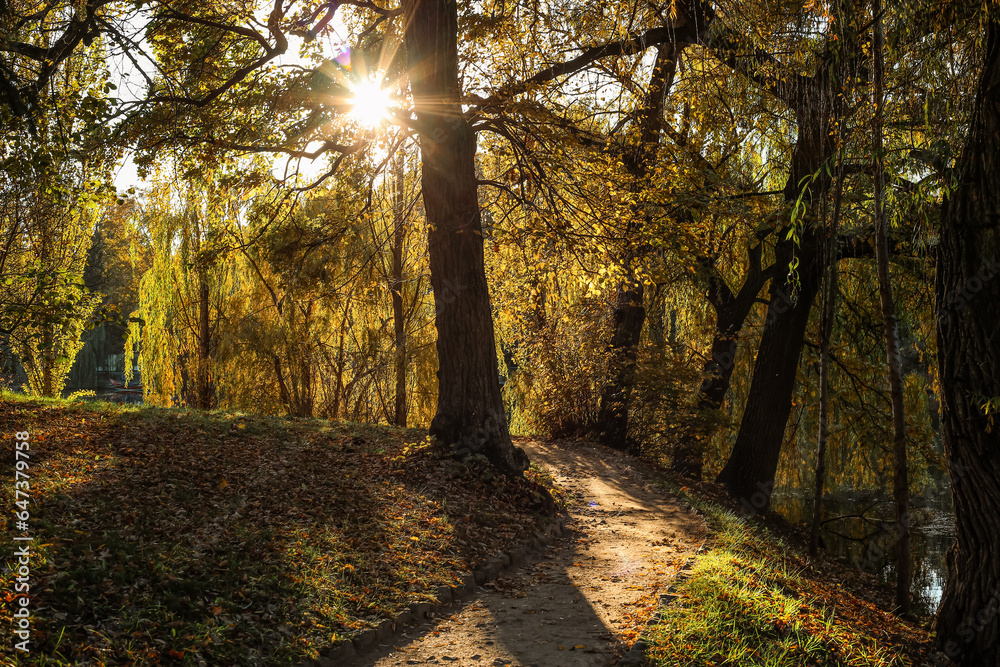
[0,394,560,666]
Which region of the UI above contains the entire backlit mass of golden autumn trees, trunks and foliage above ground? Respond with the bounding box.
[0,0,1000,664]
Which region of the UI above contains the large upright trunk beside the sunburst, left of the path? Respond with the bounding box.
[403,0,528,475]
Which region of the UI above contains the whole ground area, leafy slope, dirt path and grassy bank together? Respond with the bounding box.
[0,395,930,667]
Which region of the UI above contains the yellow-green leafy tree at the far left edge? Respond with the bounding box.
[0,35,114,396]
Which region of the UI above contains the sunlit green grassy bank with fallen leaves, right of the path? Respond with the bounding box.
[647,488,929,667]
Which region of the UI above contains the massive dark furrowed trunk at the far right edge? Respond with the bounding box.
[935,14,1000,666]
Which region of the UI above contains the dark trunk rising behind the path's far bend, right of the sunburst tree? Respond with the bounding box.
[597,43,682,451]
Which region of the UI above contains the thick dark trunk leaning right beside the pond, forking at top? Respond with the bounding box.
[704,2,900,511]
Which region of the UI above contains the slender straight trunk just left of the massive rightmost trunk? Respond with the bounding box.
[872,0,913,614]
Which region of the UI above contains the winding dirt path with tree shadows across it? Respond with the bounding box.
[359,440,704,667]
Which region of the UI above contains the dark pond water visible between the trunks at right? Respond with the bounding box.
[771,489,955,614]
